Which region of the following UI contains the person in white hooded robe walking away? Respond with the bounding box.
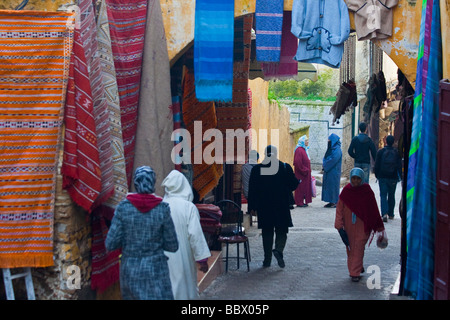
[162,170,211,300]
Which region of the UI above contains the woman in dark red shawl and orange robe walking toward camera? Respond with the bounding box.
[334,168,384,282]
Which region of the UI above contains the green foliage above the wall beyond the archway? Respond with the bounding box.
[269,69,336,101]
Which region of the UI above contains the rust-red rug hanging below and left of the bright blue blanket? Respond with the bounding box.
[182,68,223,200]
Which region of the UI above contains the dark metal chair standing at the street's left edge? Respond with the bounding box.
[216,200,251,272]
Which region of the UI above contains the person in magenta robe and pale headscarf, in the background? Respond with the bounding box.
[294,135,312,207]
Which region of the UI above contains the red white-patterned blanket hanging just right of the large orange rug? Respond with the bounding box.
[61,29,102,212]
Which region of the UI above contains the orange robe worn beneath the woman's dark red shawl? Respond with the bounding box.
[334,200,370,277]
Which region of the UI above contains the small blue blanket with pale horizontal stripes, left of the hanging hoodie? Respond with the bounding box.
[255,0,284,62]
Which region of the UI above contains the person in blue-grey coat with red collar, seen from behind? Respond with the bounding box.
[105,166,178,300]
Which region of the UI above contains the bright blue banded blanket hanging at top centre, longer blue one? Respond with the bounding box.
[194,0,234,102]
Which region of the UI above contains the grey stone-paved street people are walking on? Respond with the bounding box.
[200,175,401,300]
